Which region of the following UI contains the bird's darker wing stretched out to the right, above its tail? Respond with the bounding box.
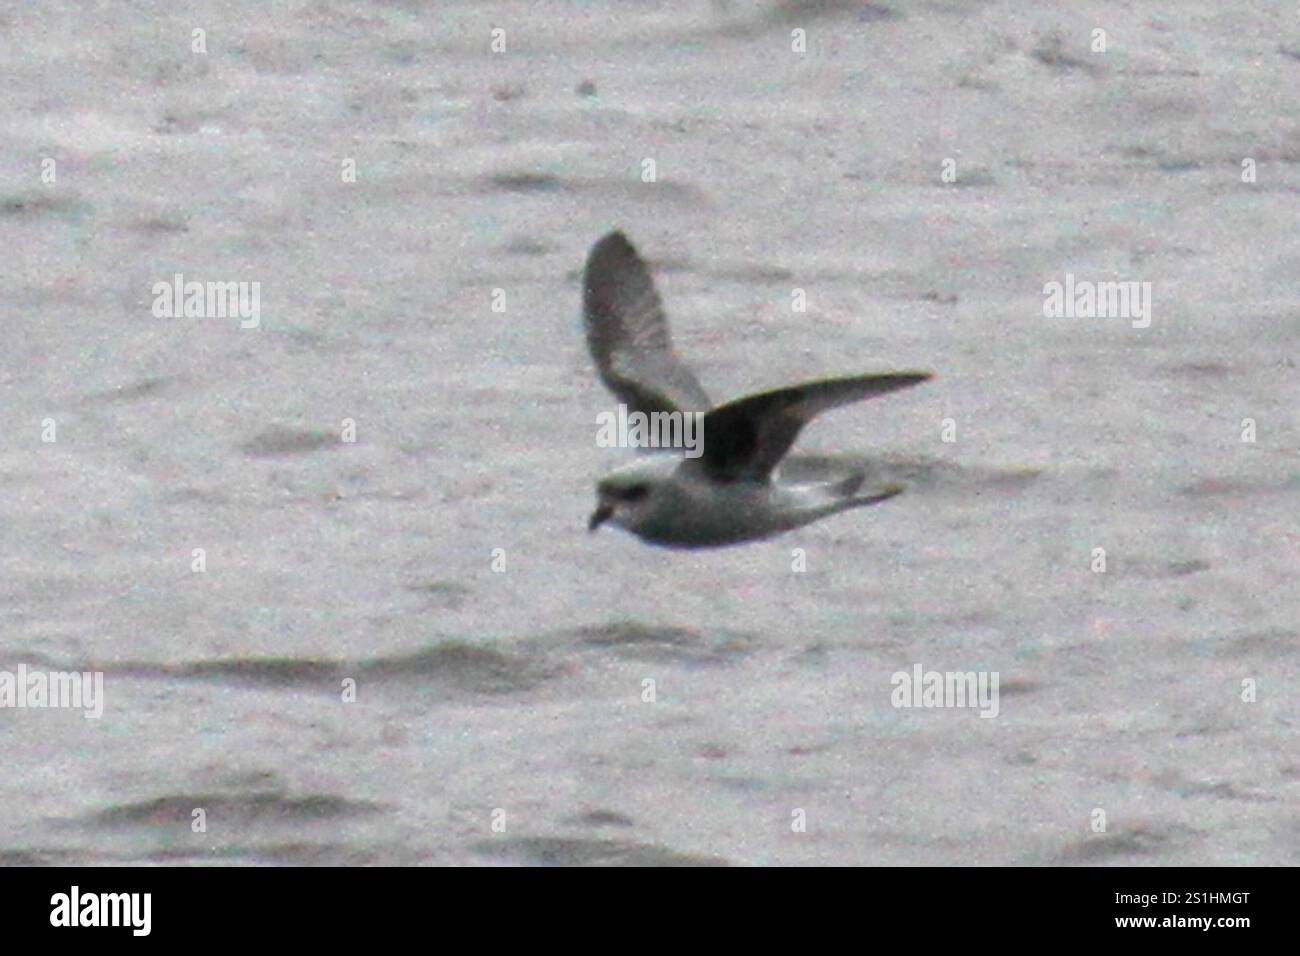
[686,372,931,481]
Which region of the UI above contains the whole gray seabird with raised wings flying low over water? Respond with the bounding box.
[584,233,930,548]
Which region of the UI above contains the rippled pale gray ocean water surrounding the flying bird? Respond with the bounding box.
[0,0,1300,865]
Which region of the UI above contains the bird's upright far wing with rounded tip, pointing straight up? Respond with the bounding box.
[582,233,711,414]
